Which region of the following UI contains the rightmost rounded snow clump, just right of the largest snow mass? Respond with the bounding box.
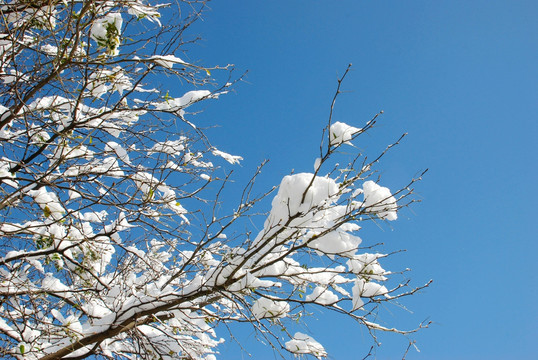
[361,180,398,221]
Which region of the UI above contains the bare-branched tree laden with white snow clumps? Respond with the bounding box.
[0,0,428,360]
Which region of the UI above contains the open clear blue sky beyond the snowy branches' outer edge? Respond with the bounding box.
[178,0,538,360]
